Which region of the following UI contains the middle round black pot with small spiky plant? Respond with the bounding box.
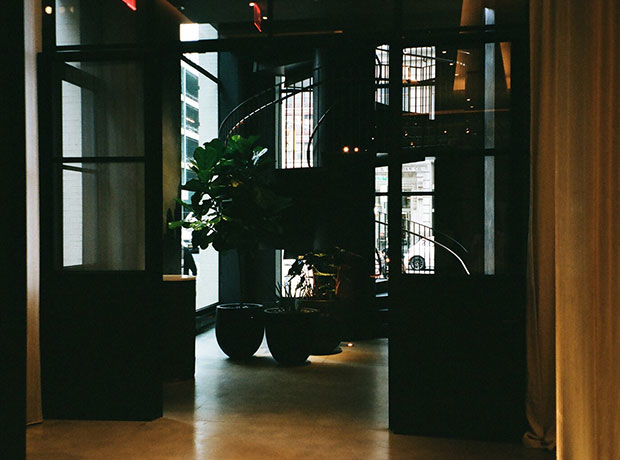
[265,308,319,366]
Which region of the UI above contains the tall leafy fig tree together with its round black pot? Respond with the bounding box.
[169,135,291,360]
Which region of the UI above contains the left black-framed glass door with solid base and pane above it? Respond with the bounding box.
[38,0,170,420]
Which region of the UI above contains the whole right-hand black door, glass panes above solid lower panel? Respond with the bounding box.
[388,24,529,439]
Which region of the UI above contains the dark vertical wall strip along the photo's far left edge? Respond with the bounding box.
[0,0,27,459]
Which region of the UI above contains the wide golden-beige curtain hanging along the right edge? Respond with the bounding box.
[526,0,620,460]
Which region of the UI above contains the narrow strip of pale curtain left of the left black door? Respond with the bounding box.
[24,0,43,424]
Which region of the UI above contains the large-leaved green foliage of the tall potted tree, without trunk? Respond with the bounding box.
[169,135,291,253]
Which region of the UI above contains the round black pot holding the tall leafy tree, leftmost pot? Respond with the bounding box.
[215,303,265,360]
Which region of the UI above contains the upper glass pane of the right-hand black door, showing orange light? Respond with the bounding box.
[402,43,511,150]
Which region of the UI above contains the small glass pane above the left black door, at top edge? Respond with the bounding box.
[55,0,140,46]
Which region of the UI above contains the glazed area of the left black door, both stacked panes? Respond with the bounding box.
[54,61,146,271]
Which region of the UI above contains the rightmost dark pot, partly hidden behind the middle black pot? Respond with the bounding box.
[302,299,343,355]
